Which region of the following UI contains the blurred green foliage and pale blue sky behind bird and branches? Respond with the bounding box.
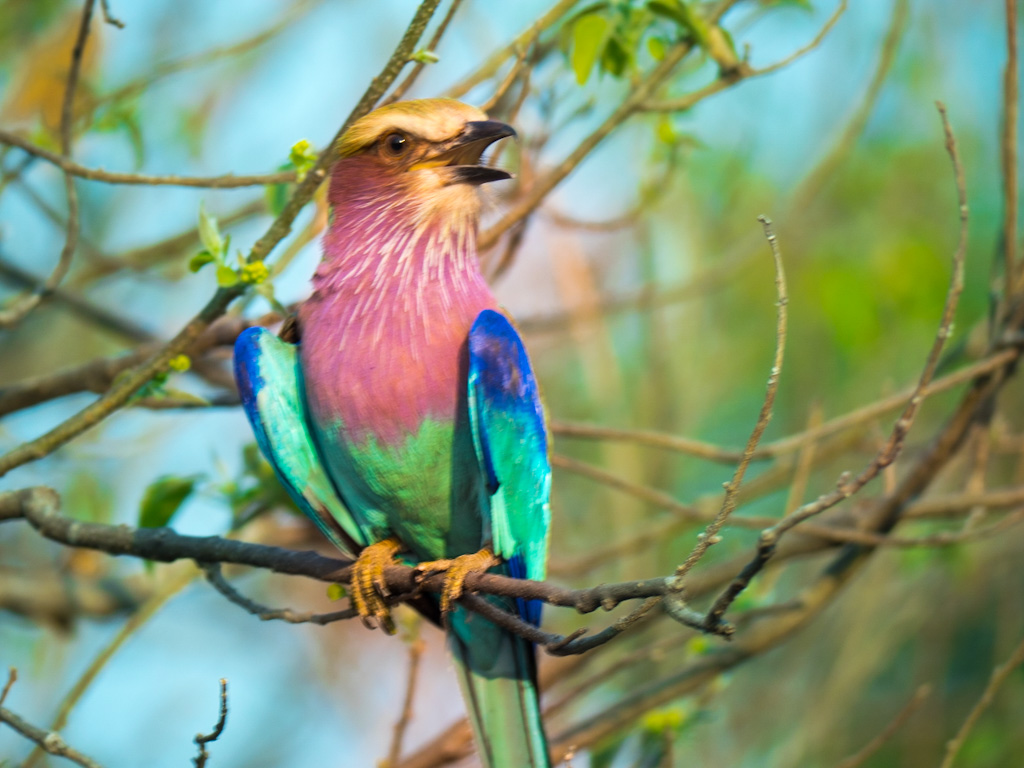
[0,0,1024,768]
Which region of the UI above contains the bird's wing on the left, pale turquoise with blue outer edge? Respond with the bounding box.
[234,328,369,557]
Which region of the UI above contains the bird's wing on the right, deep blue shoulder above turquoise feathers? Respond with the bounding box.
[468,309,551,625]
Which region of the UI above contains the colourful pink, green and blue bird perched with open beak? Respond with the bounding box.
[234,98,551,768]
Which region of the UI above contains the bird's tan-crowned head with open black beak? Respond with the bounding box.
[331,98,516,217]
